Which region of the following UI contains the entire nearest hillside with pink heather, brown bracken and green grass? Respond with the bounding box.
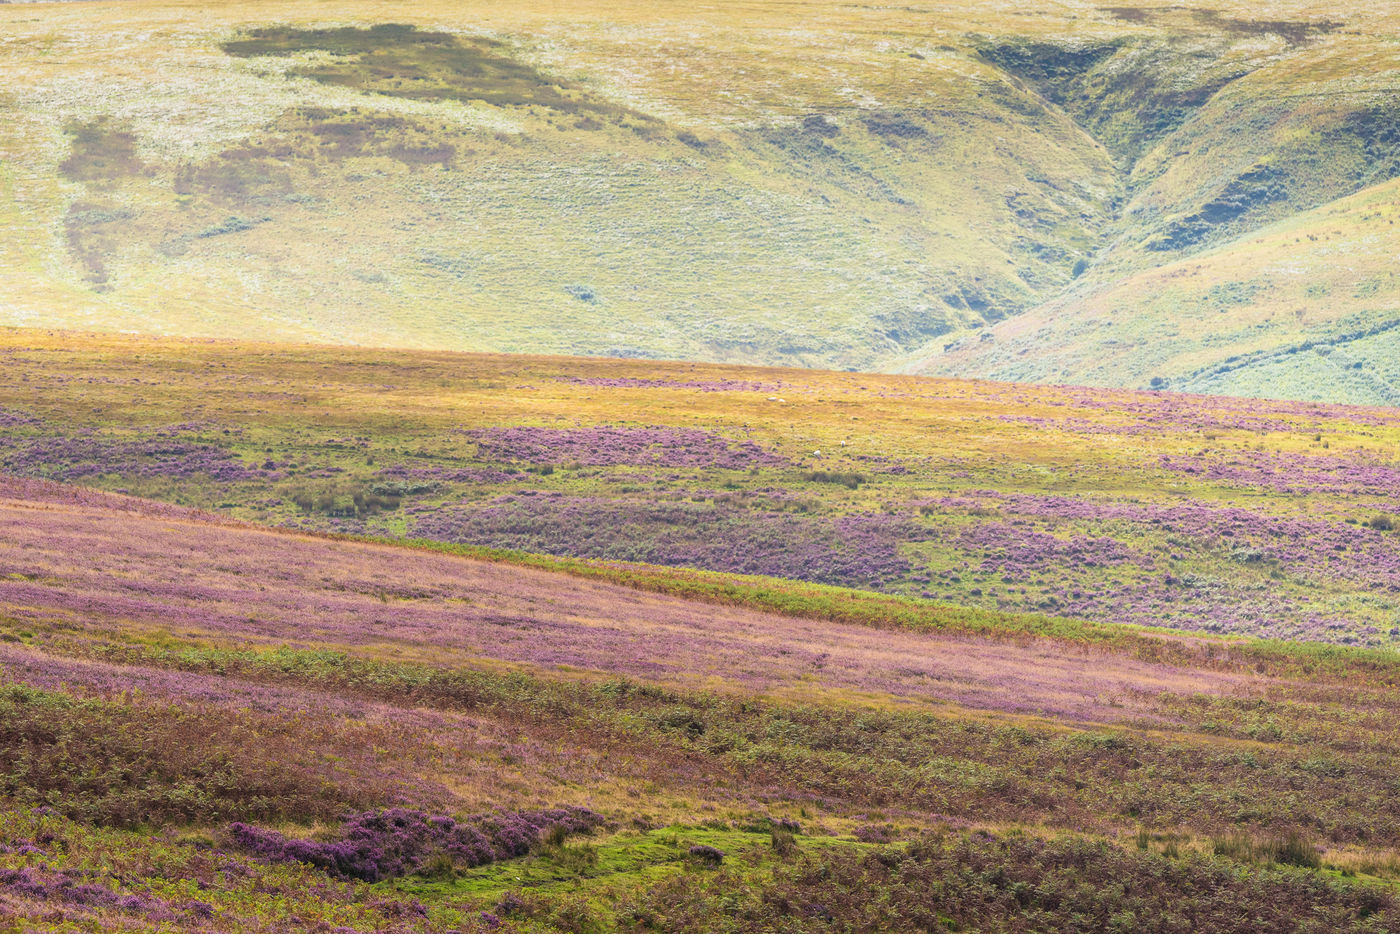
[0,478,1400,934]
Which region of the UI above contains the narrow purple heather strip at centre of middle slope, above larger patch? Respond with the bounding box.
[469,427,787,471]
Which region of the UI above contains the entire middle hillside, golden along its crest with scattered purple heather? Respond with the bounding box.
[0,330,1400,646]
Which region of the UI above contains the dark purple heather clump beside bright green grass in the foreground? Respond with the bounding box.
[230,807,602,882]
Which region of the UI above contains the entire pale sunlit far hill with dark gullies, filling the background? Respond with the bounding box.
[0,0,1400,403]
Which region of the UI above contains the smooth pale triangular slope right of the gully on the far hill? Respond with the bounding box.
[913,182,1400,406]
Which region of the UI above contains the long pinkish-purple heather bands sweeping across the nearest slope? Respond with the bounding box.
[0,490,1260,722]
